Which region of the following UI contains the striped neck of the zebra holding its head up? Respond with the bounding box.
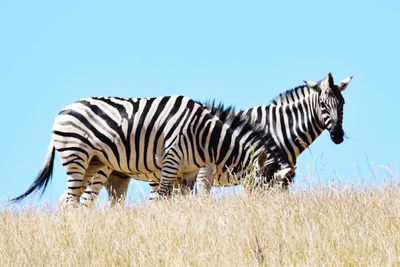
[266,88,323,164]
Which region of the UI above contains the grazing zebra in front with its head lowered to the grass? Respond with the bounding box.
[12,96,293,206]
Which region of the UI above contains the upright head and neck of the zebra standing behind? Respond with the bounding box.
[244,73,351,165]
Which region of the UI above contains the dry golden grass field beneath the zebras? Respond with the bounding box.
[0,184,400,266]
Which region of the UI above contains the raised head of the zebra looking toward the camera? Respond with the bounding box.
[304,73,353,144]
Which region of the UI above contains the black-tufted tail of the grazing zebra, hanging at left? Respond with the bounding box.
[10,142,55,203]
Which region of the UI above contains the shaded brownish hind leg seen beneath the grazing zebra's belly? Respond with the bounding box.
[105,172,130,207]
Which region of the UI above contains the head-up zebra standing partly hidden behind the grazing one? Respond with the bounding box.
[102,73,353,204]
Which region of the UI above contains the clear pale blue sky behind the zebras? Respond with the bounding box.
[0,0,400,205]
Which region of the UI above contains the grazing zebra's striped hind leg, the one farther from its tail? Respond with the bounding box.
[82,166,113,207]
